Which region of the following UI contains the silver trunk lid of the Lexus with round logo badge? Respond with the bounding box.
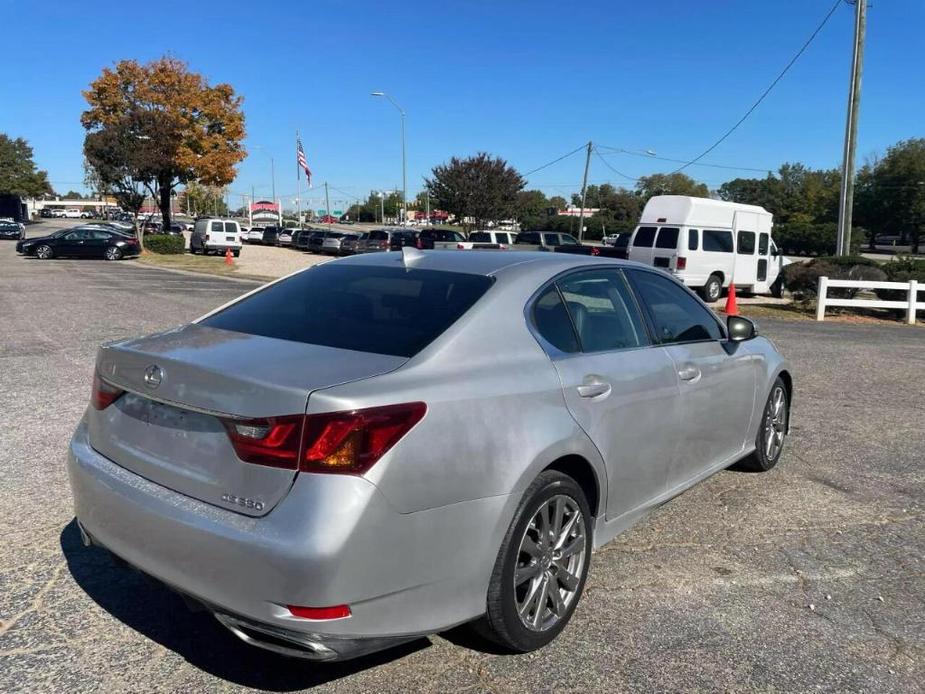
[88,324,407,516]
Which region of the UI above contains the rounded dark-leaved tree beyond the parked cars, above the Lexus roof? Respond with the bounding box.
[426,152,524,228]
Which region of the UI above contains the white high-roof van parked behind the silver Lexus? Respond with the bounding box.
[627,195,786,302]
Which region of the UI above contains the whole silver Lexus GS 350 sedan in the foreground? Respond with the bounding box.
[68,249,793,660]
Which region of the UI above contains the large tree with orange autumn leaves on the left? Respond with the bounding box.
[80,57,246,237]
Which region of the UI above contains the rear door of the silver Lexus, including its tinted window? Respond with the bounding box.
[533,268,681,519]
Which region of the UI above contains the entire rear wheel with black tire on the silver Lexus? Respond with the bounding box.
[476,470,592,653]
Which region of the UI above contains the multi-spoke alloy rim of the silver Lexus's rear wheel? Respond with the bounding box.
[514,494,587,631]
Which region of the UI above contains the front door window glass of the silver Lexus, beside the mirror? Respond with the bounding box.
[629,270,723,344]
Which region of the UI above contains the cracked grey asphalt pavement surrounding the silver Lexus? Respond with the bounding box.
[0,242,925,692]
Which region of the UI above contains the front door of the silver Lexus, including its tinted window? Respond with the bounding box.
[627,269,760,489]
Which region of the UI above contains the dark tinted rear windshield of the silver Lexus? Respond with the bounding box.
[202,263,493,357]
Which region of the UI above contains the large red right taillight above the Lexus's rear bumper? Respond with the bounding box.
[223,402,427,475]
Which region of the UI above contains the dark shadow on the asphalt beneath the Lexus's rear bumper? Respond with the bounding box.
[60,519,431,692]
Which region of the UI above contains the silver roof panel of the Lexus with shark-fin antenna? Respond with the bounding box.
[336,251,646,275]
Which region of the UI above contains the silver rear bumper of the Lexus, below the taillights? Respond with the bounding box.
[68,424,517,659]
